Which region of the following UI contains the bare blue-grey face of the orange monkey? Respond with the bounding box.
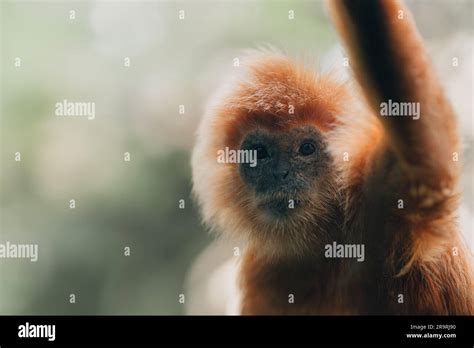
[239,126,328,217]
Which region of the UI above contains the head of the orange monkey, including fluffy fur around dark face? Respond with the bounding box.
[192,54,348,253]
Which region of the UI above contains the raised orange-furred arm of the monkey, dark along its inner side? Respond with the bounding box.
[328,0,457,196]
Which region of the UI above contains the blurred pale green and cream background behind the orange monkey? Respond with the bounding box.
[0,0,474,314]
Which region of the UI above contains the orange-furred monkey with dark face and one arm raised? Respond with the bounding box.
[192,0,474,315]
